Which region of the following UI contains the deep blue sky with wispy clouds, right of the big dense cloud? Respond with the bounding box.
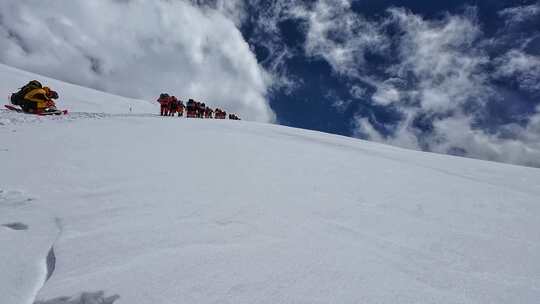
[234,0,540,165]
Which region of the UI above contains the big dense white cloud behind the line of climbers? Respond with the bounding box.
[0,0,274,121]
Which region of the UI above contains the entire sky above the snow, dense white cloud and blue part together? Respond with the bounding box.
[0,0,540,167]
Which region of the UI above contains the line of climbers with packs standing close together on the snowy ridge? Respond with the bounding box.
[157,93,240,120]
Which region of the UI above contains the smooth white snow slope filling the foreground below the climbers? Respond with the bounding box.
[0,65,540,304]
